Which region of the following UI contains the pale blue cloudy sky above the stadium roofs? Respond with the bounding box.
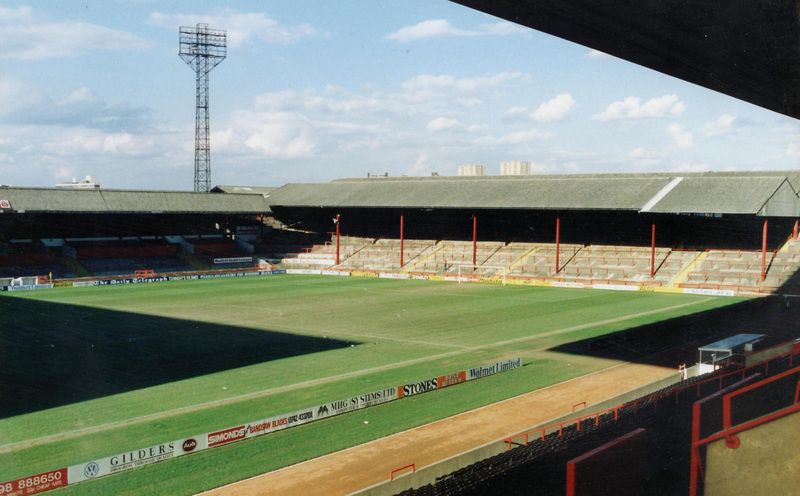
[0,0,800,190]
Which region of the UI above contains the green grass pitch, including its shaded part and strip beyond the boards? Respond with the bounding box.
[0,276,739,494]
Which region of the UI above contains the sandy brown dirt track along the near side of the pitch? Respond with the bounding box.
[203,363,676,496]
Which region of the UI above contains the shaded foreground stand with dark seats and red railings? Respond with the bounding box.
[399,343,800,496]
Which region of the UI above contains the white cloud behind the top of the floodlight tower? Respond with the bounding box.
[150,11,319,48]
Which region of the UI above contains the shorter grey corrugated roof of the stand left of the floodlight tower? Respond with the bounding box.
[0,187,269,214]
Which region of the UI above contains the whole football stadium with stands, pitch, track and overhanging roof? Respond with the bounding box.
[0,0,800,496]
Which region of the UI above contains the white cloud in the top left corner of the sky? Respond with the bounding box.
[0,7,149,60]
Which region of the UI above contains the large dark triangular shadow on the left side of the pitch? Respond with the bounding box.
[0,296,351,418]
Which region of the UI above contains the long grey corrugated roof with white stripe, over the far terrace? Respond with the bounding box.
[267,171,800,216]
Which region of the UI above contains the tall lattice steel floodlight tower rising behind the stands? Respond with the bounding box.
[178,24,223,192]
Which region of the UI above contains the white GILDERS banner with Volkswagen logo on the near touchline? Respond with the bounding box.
[67,441,178,484]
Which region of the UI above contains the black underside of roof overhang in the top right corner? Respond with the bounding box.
[452,0,800,118]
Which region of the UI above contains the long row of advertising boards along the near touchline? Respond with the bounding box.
[0,358,522,496]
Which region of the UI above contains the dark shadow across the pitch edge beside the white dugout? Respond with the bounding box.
[550,296,800,368]
